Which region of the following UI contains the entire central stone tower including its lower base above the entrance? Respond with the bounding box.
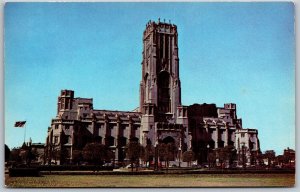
[139,20,189,151]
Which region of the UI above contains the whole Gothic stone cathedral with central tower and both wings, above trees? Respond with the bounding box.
[46,20,260,164]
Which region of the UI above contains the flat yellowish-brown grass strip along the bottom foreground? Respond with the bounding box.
[5,174,295,187]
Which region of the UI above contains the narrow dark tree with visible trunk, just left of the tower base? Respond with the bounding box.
[126,141,144,171]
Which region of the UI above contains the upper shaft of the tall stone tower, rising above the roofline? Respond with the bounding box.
[140,21,181,121]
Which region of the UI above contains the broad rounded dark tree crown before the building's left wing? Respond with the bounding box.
[82,143,111,165]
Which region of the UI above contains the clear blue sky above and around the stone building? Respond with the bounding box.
[4,3,295,154]
